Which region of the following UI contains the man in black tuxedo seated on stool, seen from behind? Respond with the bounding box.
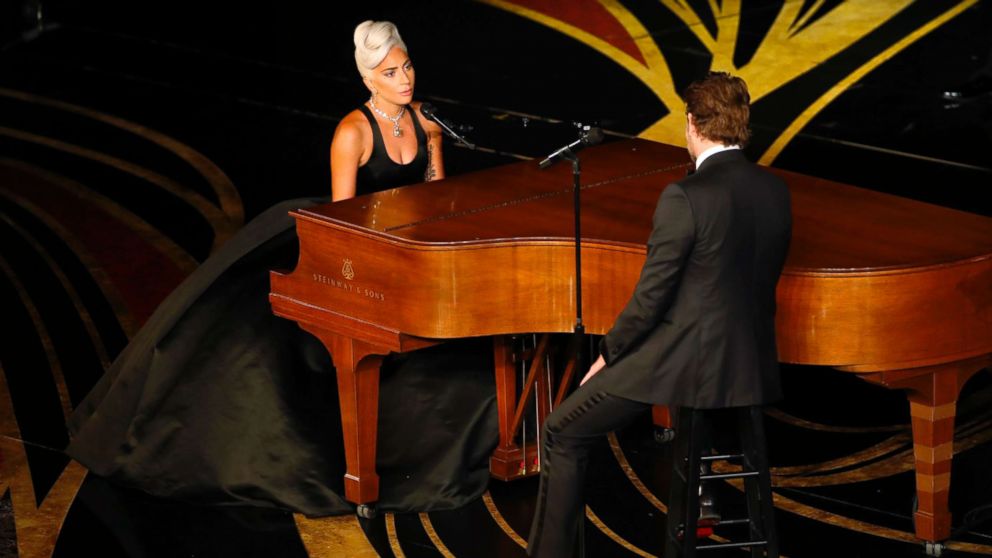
[527,72,792,557]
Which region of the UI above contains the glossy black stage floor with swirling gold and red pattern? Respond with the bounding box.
[0,0,992,558]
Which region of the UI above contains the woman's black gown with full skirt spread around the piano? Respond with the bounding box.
[66,106,498,516]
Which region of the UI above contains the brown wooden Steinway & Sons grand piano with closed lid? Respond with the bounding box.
[270,139,992,541]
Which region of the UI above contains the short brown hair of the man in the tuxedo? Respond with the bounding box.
[682,72,751,147]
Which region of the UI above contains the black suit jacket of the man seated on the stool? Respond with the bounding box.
[600,149,792,408]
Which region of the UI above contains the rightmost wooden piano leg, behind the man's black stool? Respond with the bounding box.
[861,356,990,542]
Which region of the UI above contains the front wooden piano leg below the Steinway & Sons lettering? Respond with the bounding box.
[306,327,389,513]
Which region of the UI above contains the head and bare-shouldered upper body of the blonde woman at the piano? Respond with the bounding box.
[331,20,444,201]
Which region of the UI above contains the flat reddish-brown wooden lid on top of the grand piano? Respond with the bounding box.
[295,139,992,275]
